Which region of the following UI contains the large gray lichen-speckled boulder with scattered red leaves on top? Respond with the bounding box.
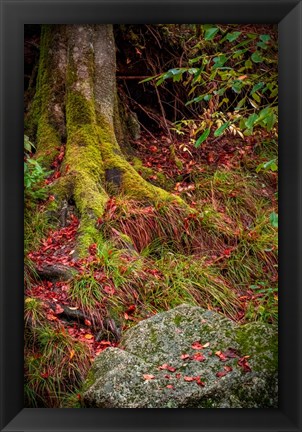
[83,305,278,408]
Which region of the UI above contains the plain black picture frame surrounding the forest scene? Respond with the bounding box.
[0,0,302,432]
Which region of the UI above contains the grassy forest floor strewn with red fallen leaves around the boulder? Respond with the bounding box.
[25,126,278,406]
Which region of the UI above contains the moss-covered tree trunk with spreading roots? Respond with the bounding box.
[26,25,185,251]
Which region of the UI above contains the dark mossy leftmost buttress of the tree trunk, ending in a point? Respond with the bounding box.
[25,25,67,168]
